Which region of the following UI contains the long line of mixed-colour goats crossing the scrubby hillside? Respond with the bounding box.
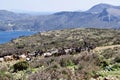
[0,41,95,62]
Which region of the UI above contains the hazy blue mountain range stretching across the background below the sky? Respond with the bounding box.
[0,4,120,31]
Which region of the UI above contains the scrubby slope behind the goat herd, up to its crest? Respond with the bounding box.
[0,28,120,54]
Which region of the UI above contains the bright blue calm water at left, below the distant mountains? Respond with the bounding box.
[0,31,36,44]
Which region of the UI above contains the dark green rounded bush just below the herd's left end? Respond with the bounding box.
[13,61,29,72]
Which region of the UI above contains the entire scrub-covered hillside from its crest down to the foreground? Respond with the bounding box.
[0,28,120,80]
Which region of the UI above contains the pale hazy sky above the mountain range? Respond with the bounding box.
[0,0,120,12]
